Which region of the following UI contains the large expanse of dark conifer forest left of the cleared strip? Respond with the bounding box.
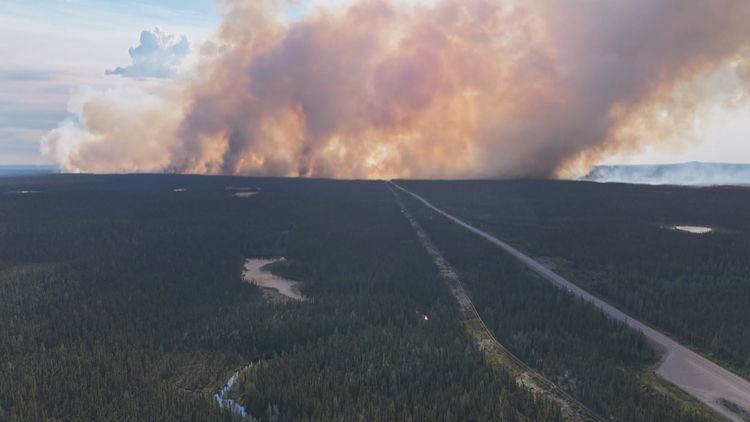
[0,175,560,421]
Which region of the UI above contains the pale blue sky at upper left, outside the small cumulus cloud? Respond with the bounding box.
[0,0,220,164]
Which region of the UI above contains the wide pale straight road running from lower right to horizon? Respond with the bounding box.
[393,183,750,422]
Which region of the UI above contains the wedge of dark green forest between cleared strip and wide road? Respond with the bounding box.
[406,190,713,421]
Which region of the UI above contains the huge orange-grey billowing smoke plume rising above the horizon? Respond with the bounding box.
[43,0,750,178]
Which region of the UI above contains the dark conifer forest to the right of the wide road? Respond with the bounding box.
[404,181,750,376]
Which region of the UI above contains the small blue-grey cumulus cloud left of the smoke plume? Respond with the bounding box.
[106,28,190,79]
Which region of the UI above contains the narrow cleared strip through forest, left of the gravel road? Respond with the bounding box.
[386,182,603,421]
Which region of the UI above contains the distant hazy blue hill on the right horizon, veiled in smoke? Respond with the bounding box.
[580,162,750,186]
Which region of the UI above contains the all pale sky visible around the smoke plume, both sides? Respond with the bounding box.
[0,0,750,172]
